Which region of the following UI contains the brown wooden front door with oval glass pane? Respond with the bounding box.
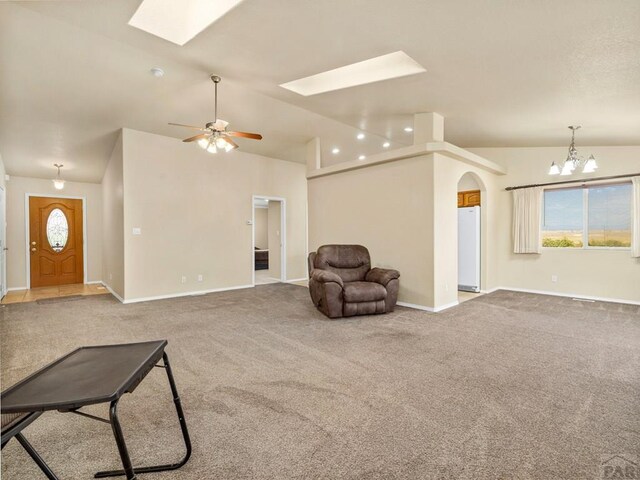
[29,197,84,288]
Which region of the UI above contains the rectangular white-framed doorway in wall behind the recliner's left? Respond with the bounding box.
[251,195,287,285]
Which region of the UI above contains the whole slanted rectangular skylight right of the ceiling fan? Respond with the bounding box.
[280,50,427,97]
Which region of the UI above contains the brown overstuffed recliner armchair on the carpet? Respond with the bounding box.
[309,245,400,318]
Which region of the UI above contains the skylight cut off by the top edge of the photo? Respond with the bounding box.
[129,0,243,46]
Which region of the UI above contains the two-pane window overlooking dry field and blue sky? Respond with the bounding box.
[542,183,631,248]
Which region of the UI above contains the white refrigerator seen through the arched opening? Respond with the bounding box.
[458,207,480,292]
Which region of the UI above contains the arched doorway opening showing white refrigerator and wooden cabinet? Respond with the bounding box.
[457,172,482,303]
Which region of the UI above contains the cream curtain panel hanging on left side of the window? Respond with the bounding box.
[513,187,542,253]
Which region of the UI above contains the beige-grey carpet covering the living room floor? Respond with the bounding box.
[0,284,640,480]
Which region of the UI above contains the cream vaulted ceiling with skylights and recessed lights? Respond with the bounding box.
[0,0,640,182]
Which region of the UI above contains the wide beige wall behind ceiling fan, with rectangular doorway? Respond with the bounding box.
[123,129,307,300]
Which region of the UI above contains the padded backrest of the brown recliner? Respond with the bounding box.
[314,245,371,282]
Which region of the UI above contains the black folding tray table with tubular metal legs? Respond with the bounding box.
[0,340,191,480]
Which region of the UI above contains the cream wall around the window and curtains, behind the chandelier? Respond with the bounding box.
[469,146,640,302]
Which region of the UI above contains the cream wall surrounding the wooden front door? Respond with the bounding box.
[6,176,102,289]
